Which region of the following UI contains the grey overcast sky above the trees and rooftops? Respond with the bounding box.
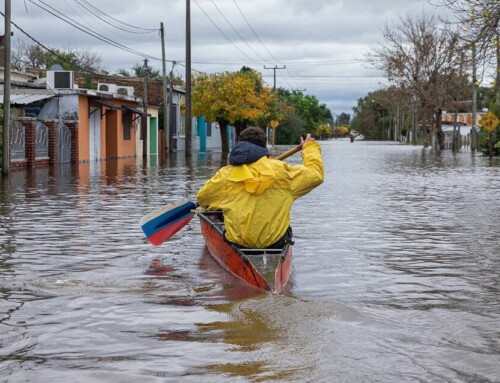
[6,0,454,115]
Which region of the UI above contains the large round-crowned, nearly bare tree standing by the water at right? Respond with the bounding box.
[371,15,466,149]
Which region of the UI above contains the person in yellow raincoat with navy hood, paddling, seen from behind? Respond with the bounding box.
[197,127,324,249]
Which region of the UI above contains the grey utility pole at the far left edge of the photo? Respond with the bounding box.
[2,0,11,176]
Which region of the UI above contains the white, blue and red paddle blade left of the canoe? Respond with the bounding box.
[141,200,196,246]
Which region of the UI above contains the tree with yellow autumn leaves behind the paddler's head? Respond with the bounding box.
[191,71,273,154]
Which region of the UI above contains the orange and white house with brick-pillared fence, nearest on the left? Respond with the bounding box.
[2,70,159,167]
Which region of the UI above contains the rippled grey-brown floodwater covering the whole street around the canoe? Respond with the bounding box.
[0,141,500,383]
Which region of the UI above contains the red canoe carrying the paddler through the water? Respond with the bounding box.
[198,211,292,294]
